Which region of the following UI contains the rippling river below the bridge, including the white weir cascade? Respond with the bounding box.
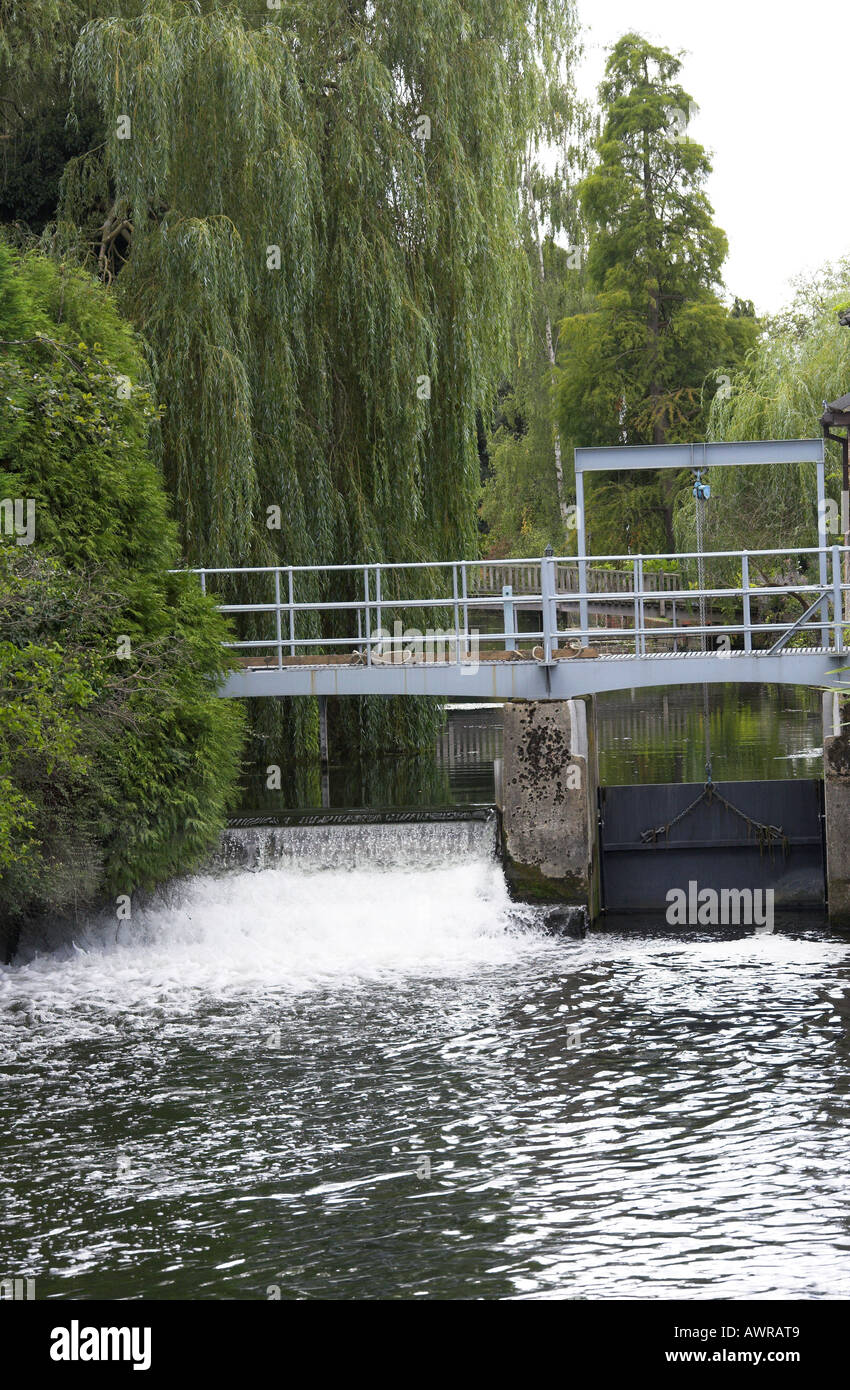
[0,689,850,1300]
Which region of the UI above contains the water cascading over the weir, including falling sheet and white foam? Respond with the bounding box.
[9,816,561,997]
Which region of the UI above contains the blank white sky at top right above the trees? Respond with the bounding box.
[578,0,850,313]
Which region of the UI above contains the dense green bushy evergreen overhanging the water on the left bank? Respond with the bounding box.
[0,240,243,927]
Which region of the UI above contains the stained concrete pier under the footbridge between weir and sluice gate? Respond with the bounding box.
[500,699,600,920]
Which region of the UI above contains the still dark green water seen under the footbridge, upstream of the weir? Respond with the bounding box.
[242,685,824,815]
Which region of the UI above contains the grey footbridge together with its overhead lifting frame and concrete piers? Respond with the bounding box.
[180,439,850,927]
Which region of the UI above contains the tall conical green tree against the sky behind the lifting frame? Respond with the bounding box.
[560,33,756,553]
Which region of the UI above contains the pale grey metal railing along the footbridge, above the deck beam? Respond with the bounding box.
[174,545,850,667]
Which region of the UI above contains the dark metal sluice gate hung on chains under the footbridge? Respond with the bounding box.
[599,780,825,912]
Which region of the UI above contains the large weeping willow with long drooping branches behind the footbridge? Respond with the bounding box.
[54,0,575,751]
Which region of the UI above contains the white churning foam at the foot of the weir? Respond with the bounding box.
[0,858,543,1012]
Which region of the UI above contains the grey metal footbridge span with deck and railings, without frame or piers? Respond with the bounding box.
[180,545,850,701]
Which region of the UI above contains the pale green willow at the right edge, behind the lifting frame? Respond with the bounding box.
[676,261,850,564]
